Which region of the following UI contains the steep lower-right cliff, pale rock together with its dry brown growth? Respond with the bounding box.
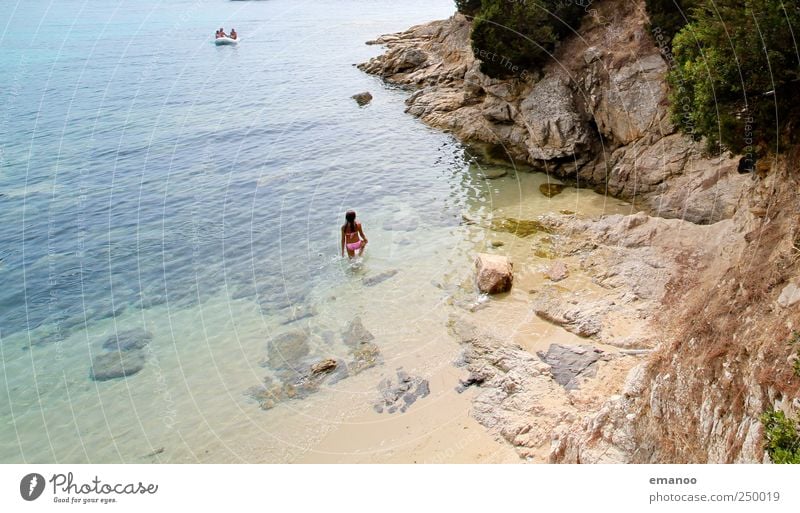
[550,158,800,463]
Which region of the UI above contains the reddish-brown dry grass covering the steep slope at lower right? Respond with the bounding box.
[635,152,800,463]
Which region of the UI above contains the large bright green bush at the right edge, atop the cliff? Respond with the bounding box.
[668,0,800,156]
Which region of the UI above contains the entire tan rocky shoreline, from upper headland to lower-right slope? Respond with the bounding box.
[359,0,800,463]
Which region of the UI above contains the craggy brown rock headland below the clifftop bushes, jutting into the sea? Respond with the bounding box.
[359,0,746,223]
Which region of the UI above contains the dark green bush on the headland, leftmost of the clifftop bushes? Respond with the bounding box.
[472,0,589,78]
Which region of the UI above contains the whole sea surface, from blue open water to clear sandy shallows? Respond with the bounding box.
[0,0,623,463]
